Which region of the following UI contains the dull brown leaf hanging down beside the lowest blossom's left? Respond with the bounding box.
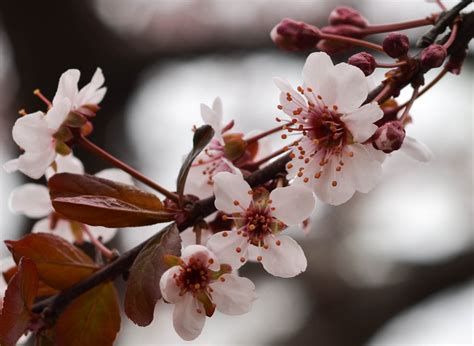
[125,224,181,326]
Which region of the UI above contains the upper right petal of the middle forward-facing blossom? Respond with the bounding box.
[270,185,316,226]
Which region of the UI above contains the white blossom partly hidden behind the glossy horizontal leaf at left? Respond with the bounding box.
[9,154,133,243]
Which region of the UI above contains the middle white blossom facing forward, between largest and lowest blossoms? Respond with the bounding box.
[207,172,315,277]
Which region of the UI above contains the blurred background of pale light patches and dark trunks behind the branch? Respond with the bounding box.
[0,0,474,346]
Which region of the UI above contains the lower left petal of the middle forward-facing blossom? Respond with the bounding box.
[206,231,249,270]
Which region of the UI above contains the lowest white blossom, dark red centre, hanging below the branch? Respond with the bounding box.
[160,245,256,340]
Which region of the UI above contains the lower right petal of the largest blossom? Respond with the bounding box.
[342,144,382,193]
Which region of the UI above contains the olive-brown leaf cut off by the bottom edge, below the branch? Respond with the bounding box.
[55,283,120,346]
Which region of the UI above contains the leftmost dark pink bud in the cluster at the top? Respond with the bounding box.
[270,18,319,51]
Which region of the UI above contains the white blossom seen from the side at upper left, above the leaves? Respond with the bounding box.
[3,69,106,179]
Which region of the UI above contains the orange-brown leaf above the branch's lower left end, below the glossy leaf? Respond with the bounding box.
[5,233,99,290]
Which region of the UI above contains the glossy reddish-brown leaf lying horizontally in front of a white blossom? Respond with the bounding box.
[48,173,174,227]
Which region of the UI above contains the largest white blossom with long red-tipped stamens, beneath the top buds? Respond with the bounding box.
[275,53,384,205]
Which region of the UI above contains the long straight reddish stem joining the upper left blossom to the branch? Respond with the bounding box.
[76,135,179,202]
